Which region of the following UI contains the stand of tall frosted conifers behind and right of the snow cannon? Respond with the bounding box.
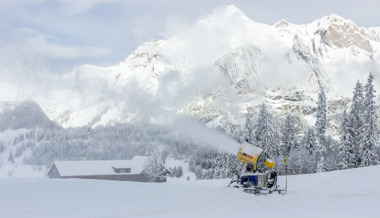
[244,74,379,174]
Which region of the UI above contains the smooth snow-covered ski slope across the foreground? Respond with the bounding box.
[0,166,380,218]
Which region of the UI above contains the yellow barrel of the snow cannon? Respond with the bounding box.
[237,142,275,171]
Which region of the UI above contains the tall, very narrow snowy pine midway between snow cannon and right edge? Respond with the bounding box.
[315,88,327,173]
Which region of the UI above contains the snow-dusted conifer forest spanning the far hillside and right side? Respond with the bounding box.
[0,74,380,179]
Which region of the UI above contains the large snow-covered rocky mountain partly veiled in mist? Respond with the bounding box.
[0,6,380,132]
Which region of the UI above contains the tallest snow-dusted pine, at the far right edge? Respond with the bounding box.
[359,73,379,166]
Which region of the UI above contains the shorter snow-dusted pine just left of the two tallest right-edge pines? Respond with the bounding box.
[339,110,357,169]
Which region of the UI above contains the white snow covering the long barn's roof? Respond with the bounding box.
[49,156,148,176]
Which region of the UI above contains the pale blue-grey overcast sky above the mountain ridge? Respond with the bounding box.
[0,0,380,75]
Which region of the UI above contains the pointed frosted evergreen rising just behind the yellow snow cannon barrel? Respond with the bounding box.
[253,104,278,156]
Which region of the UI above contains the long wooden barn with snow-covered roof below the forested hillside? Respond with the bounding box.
[47,156,170,182]
